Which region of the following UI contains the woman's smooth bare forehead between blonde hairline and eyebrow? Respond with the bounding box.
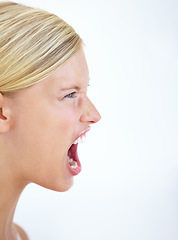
[8,48,89,102]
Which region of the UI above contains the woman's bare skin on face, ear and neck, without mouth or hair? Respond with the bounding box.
[0,48,100,240]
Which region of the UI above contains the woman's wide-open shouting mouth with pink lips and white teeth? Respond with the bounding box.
[67,129,89,176]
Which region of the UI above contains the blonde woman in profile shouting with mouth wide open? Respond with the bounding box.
[0,2,100,240]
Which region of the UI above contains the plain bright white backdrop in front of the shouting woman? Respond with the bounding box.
[15,0,178,240]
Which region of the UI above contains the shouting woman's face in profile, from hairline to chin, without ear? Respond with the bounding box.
[6,48,100,191]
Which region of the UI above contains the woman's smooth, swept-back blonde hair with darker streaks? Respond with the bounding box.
[0,2,82,94]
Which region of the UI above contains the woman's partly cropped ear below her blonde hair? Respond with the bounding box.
[0,93,11,134]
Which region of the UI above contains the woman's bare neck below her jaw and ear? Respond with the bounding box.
[0,172,25,240]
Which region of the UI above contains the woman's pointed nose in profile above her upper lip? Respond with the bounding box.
[80,97,101,123]
